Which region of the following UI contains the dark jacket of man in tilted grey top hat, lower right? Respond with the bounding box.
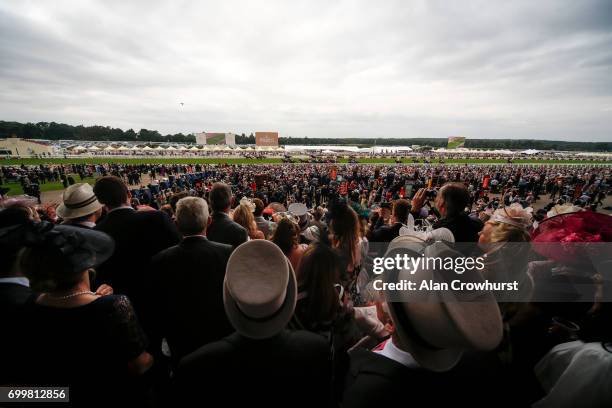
[343,349,507,408]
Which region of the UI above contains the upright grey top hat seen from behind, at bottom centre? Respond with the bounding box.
[223,239,297,339]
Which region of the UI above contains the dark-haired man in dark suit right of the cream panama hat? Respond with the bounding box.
[94,176,181,342]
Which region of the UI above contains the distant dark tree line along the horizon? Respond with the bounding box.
[0,121,612,152]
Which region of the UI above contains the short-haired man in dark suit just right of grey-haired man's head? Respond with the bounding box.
[207,183,249,248]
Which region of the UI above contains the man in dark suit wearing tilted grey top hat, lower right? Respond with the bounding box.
[343,241,504,408]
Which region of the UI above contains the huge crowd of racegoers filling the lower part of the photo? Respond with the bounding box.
[0,164,612,407]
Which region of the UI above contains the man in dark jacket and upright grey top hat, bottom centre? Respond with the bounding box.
[174,239,331,407]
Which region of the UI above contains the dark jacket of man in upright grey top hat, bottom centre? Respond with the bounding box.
[175,331,331,407]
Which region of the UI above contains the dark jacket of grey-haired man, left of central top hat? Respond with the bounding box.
[153,236,234,363]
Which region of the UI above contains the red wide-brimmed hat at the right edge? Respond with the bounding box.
[531,211,612,265]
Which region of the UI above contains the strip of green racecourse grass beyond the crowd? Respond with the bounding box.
[0,157,612,166]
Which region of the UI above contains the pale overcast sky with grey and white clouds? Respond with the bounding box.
[0,0,612,141]
